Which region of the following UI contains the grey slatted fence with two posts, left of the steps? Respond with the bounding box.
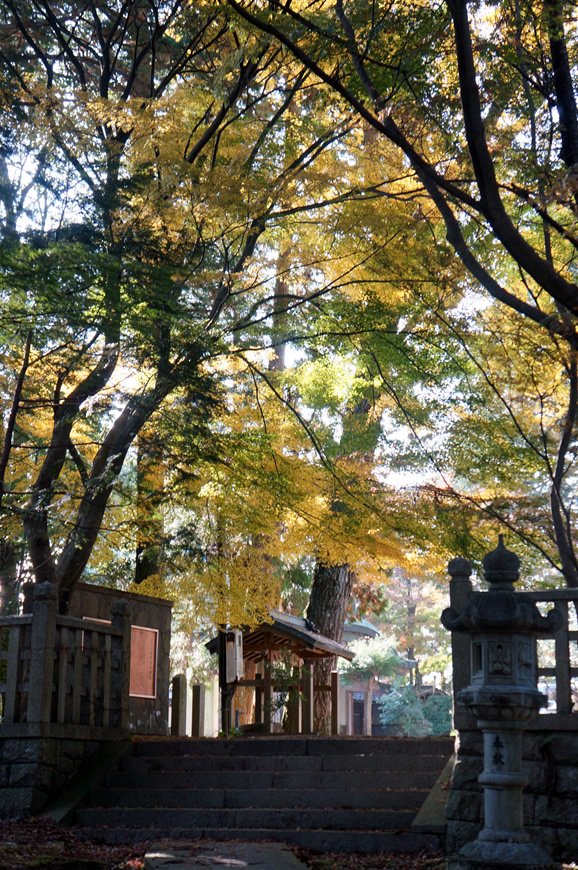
[0,583,130,730]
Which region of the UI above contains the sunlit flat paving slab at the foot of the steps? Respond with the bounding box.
[144,840,306,870]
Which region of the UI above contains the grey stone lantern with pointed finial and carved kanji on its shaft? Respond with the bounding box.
[441,535,560,870]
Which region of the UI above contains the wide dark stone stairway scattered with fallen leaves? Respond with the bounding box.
[72,737,453,853]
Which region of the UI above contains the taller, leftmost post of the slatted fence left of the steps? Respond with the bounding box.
[26,583,58,722]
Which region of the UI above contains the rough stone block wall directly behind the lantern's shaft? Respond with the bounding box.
[446,715,578,863]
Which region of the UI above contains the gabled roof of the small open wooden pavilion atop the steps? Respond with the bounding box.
[206,610,353,661]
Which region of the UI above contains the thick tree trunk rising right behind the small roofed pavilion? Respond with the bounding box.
[307,562,355,734]
